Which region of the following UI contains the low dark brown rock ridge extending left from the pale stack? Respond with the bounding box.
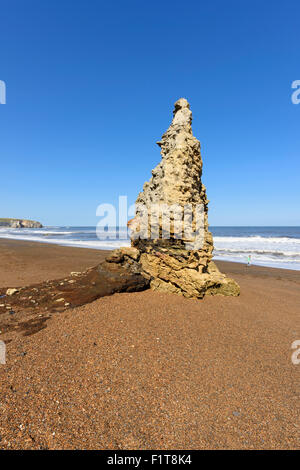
[0,261,149,336]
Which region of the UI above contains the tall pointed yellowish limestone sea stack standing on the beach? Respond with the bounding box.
[107,98,240,298]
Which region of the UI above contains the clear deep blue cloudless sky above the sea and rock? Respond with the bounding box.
[0,0,300,225]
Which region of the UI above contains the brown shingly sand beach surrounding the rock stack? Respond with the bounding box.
[0,240,300,449]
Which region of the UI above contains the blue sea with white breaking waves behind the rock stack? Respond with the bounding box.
[0,226,300,270]
